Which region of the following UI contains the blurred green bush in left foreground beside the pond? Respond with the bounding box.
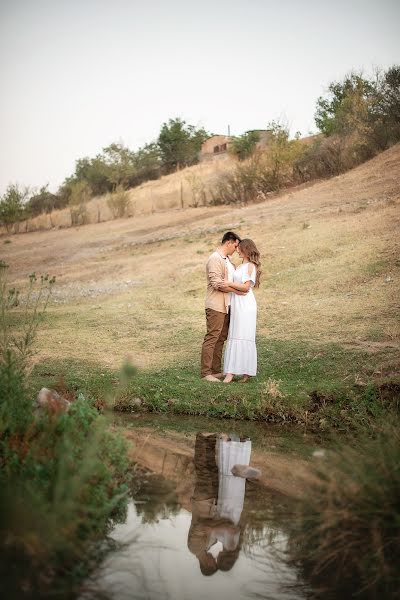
[0,265,130,598]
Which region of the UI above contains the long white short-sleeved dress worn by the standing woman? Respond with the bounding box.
[224,263,257,376]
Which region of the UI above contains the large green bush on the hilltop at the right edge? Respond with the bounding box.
[314,65,400,180]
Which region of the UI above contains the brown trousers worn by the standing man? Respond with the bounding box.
[201,308,230,377]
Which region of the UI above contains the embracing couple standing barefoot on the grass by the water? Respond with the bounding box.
[201,231,261,383]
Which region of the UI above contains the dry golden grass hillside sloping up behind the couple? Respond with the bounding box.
[1,145,400,378]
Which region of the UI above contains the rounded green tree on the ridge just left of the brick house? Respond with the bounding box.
[157,118,210,173]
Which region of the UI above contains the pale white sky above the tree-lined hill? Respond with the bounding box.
[0,0,400,194]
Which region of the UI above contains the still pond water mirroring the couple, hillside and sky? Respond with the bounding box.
[88,415,317,600]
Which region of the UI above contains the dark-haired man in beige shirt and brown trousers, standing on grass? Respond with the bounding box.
[201,231,240,382]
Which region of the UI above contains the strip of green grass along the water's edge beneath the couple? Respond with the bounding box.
[28,338,400,431]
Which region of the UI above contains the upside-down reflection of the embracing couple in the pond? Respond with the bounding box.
[188,433,251,575]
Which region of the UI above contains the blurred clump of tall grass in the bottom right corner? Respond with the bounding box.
[290,426,400,599]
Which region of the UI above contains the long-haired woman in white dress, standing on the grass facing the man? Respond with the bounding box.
[220,239,261,383]
